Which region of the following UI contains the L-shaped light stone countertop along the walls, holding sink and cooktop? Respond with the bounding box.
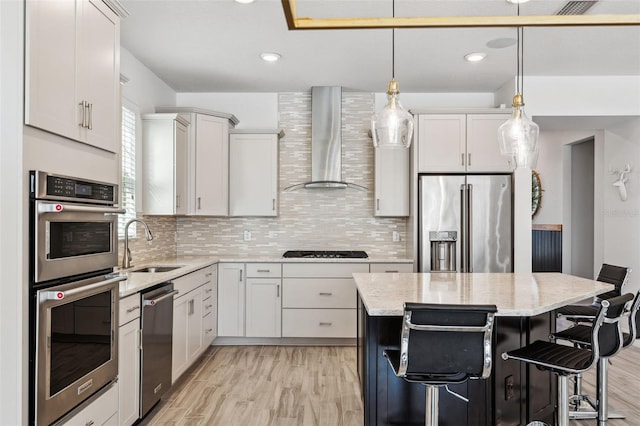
[115,254,413,298]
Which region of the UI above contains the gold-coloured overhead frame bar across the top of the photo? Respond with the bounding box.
[282,0,640,30]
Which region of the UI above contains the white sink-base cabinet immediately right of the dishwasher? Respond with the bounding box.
[171,266,216,384]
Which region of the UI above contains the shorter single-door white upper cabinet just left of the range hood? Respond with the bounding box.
[229,130,279,216]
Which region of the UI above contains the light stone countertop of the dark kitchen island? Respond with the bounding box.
[353,272,613,316]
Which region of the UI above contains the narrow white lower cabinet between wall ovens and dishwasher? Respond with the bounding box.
[116,293,140,426]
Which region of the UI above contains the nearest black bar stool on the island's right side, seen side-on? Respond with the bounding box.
[502,293,633,426]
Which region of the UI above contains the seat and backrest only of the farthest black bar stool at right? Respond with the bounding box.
[556,263,631,323]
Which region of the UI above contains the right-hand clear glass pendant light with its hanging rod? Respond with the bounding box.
[498,4,540,169]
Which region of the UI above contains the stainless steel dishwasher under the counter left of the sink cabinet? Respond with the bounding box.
[140,283,178,418]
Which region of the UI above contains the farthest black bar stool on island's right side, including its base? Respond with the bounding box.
[556,263,631,411]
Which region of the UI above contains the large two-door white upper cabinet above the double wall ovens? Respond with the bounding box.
[25,0,120,153]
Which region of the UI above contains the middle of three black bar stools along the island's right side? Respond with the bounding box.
[549,292,640,421]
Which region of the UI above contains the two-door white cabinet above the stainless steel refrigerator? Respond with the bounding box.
[418,113,512,173]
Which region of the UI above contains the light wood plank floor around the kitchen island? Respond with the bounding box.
[141,346,640,426]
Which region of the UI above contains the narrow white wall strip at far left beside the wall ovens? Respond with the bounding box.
[0,0,28,425]
